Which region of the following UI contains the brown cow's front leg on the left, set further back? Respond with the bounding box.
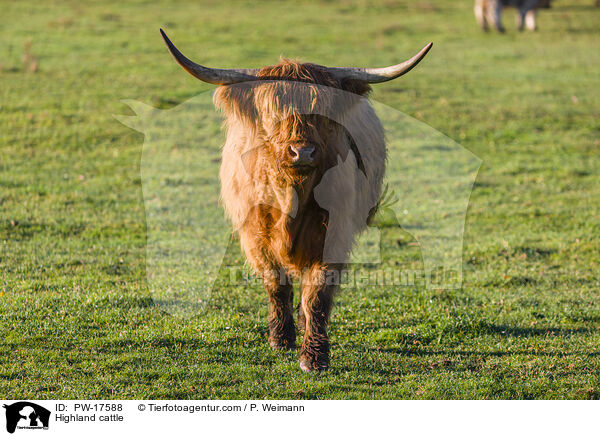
[263,271,296,350]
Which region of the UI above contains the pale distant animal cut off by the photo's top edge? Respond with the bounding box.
[475,0,550,32]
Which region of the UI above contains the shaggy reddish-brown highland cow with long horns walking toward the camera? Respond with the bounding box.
[161,30,432,371]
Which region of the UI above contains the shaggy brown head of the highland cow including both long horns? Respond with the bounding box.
[161,29,432,182]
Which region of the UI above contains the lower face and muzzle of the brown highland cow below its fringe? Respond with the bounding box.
[263,115,333,178]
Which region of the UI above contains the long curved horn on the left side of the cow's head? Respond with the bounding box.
[160,29,258,85]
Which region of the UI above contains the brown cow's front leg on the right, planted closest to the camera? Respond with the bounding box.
[300,265,339,372]
